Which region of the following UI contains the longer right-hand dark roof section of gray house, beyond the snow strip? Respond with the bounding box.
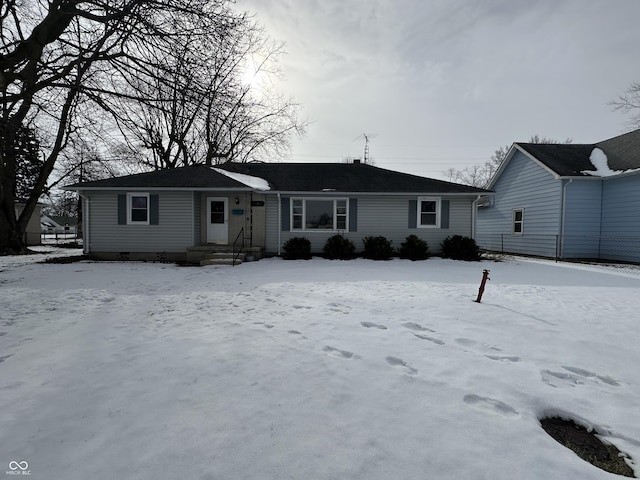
[221,163,487,194]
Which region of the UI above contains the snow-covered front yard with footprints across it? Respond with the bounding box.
[0,251,640,480]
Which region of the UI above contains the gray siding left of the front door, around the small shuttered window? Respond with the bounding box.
[84,190,194,253]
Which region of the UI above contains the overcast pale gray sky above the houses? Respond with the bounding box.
[237,0,640,178]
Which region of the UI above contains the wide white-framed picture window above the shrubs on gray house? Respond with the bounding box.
[291,198,349,231]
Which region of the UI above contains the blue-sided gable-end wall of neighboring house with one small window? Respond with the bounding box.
[476,152,562,257]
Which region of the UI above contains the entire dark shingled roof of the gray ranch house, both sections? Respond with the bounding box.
[67,163,488,194]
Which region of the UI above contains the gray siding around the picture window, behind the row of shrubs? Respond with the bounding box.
[266,194,474,254]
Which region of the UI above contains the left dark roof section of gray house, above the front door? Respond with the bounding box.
[66,165,247,190]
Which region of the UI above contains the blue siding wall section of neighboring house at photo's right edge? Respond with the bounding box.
[600,175,640,262]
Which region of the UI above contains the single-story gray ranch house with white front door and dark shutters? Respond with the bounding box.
[67,163,491,263]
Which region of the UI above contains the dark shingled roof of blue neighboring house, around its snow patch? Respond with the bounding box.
[516,129,640,177]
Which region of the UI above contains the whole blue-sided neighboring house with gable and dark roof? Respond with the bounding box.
[476,130,640,263]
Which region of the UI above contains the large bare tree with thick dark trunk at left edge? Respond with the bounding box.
[0,0,235,252]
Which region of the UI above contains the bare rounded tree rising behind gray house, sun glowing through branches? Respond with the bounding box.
[114,15,306,169]
